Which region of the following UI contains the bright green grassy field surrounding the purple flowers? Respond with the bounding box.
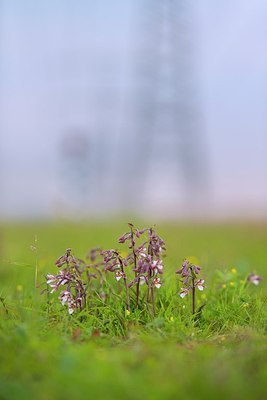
[0,221,267,400]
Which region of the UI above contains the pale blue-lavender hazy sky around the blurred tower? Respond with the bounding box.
[0,0,267,217]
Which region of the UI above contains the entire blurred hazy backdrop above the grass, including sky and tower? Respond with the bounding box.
[0,0,267,220]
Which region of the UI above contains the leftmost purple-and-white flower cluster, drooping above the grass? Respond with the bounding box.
[46,249,86,314]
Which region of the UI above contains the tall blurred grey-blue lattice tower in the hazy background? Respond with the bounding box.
[124,0,206,212]
